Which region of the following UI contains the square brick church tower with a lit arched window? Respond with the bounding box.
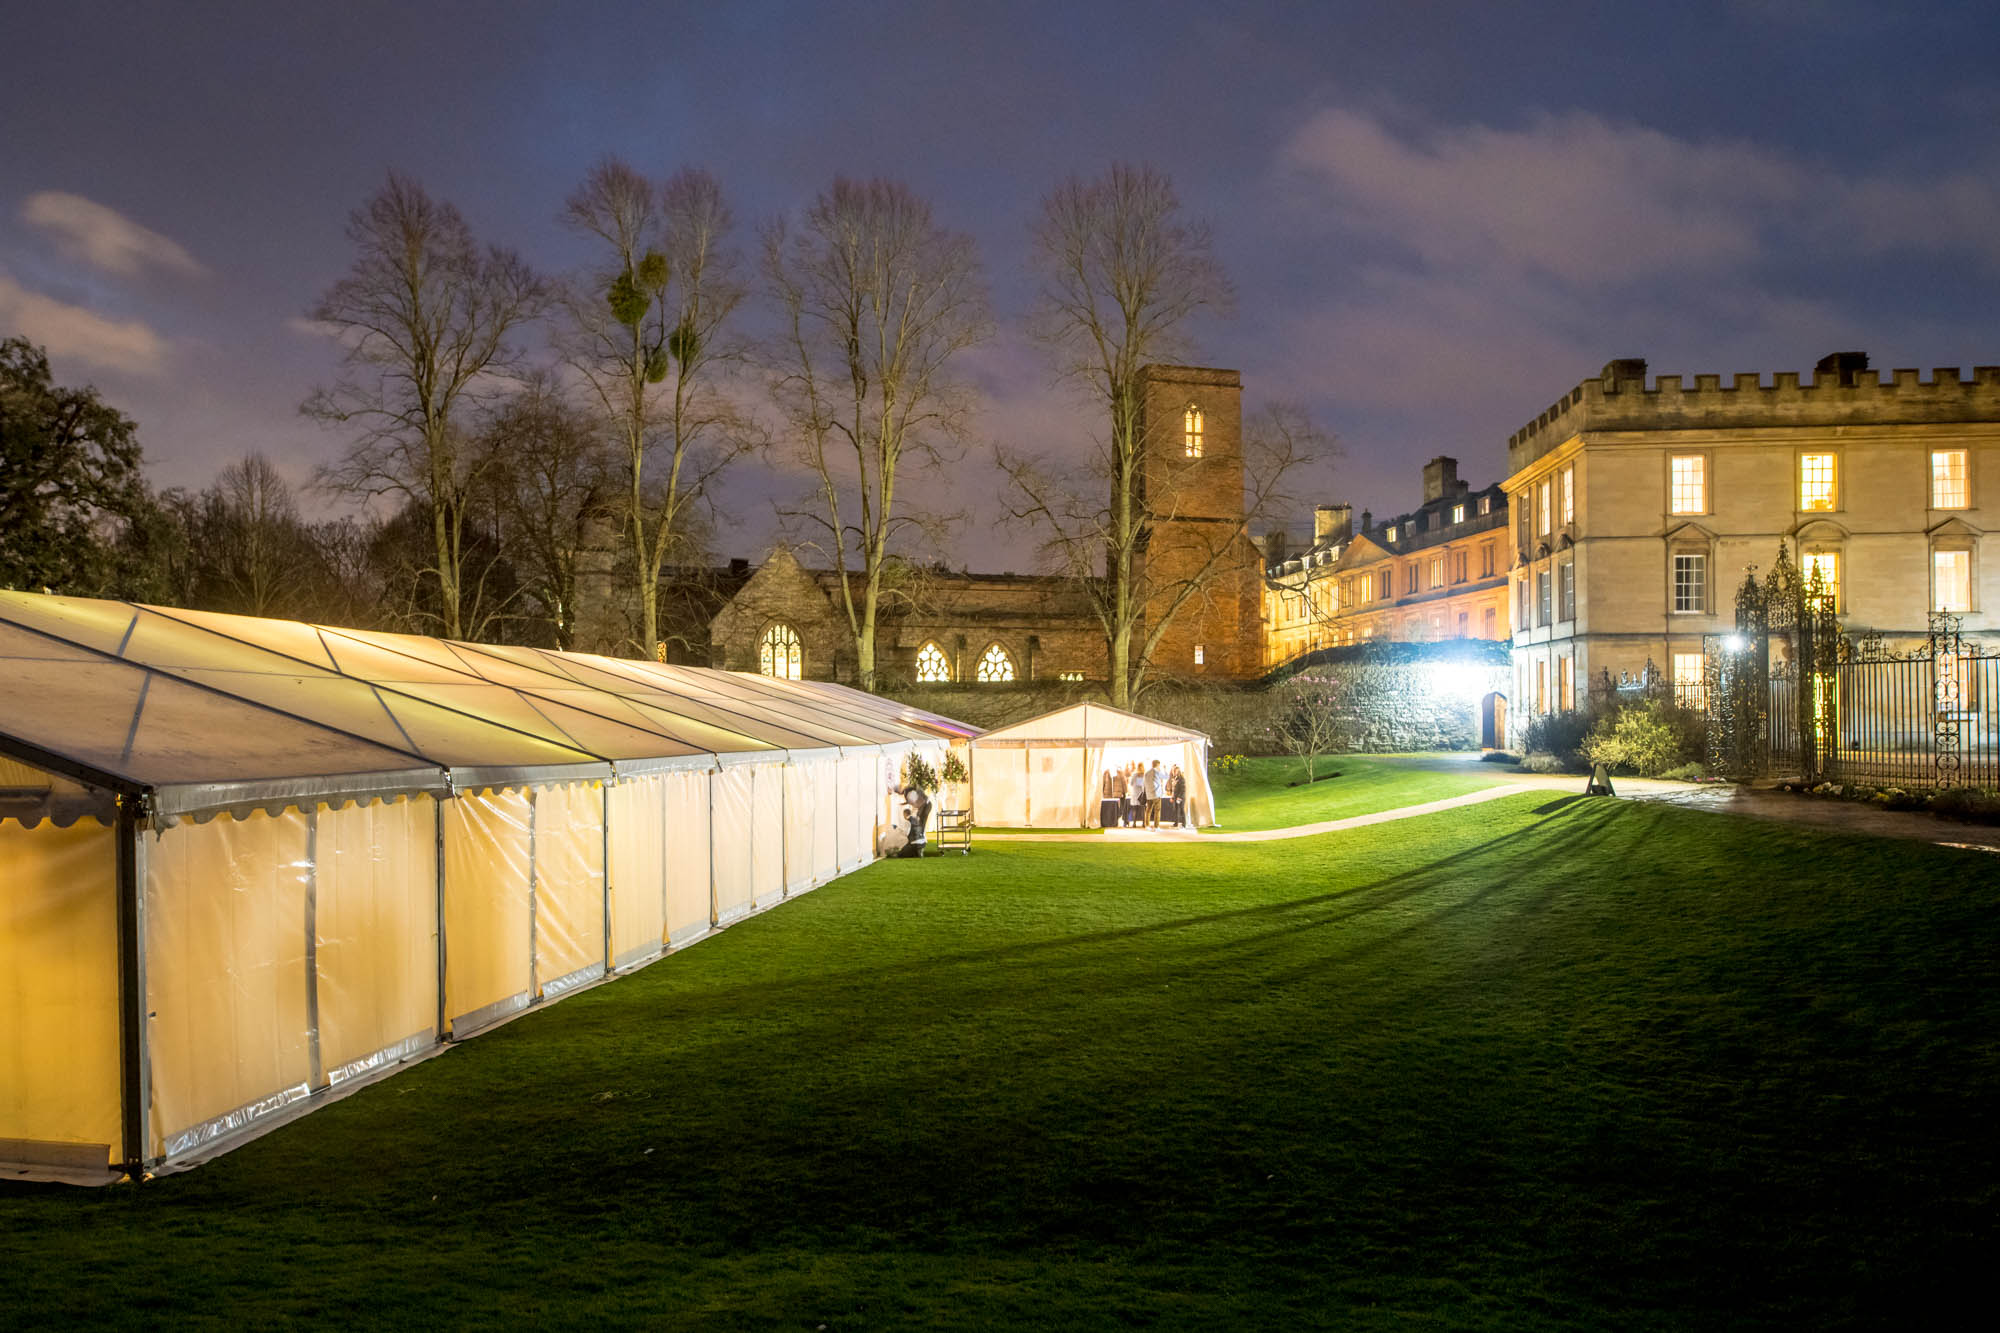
[1140,366,1264,677]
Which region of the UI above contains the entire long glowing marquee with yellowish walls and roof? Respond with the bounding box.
[0,592,976,1177]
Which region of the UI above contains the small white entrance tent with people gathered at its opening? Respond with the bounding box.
[972,703,1216,829]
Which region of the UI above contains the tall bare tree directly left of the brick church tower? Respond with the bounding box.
[1002,164,1230,707]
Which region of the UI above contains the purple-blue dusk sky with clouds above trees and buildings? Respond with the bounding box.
[0,0,2000,568]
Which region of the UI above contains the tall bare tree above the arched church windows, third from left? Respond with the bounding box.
[764,178,992,689]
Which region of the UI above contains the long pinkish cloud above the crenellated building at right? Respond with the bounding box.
[1280,108,2000,288]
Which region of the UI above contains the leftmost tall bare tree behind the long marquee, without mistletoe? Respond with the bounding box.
[302,174,546,638]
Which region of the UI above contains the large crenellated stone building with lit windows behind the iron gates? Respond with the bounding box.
[1504,352,2000,725]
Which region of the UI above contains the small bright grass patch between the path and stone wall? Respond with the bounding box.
[1208,755,1502,831]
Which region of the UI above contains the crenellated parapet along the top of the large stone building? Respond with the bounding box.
[1508,352,2000,472]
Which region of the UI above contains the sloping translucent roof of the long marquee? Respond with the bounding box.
[0,590,972,809]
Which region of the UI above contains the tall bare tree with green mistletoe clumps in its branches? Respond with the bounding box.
[562,158,752,656]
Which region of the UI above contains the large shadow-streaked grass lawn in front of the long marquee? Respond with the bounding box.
[0,792,2000,1331]
